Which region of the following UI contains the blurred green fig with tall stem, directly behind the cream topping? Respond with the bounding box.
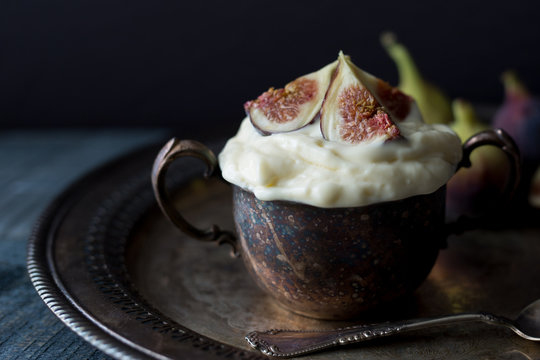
[381,33,452,124]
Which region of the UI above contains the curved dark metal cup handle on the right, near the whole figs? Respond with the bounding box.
[446,129,521,235]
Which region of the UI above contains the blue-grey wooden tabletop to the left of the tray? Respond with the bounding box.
[0,129,167,360]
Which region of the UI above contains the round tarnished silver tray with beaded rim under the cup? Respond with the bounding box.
[28,144,540,359]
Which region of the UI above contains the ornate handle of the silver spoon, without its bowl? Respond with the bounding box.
[246,313,506,358]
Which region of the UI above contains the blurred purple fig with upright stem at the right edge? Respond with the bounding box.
[493,71,540,207]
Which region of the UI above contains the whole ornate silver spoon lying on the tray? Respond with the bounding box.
[246,299,540,358]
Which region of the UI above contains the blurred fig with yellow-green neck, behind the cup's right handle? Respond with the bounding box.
[446,99,509,218]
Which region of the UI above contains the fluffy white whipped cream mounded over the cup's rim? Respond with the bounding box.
[219,107,462,208]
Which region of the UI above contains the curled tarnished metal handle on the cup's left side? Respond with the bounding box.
[152,138,239,256]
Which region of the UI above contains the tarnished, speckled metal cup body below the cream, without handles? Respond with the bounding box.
[233,186,445,319]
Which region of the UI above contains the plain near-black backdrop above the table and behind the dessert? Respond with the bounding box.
[0,0,540,136]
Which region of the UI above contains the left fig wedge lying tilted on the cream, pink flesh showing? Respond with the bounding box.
[244,61,338,135]
